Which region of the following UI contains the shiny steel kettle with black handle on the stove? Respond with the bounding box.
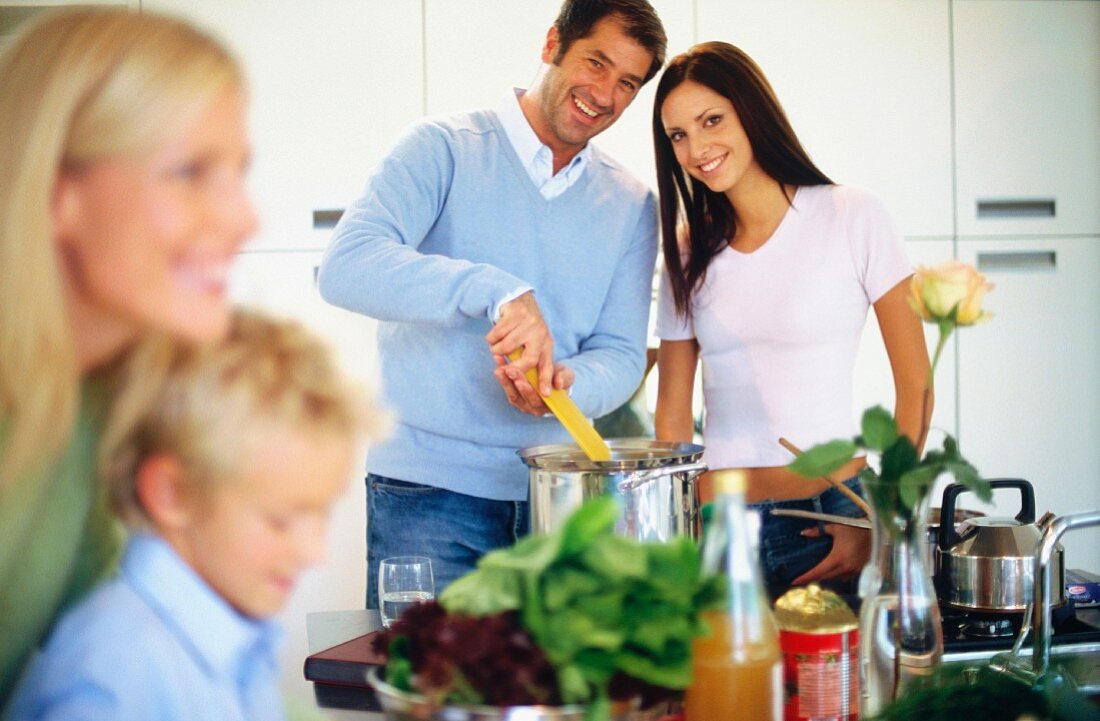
[937,479,1066,613]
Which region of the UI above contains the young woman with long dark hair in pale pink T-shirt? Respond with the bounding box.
[653,42,931,590]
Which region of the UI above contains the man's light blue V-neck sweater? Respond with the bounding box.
[319,111,657,501]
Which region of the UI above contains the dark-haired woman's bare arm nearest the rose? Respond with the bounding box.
[875,277,934,455]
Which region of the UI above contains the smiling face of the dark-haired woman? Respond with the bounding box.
[661,80,763,193]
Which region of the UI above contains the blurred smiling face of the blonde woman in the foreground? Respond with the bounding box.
[54,89,257,341]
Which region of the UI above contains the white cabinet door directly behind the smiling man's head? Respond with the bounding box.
[425,0,694,189]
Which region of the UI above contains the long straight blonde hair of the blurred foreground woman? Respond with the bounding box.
[0,8,243,484]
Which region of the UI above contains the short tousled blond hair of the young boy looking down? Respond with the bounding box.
[101,308,380,527]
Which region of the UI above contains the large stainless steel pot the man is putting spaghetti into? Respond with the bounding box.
[519,438,706,540]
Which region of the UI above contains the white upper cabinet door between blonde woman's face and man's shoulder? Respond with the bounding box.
[142,0,424,249]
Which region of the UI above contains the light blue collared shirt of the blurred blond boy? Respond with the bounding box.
[9,535,285,721]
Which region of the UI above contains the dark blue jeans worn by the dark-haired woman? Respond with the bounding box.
[748,477,870,593]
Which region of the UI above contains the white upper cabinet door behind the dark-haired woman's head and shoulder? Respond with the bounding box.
[697,0,954,238]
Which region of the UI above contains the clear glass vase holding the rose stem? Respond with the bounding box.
[859,473,944,718]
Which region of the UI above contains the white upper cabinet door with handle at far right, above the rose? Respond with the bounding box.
[954,0,1100,237]
